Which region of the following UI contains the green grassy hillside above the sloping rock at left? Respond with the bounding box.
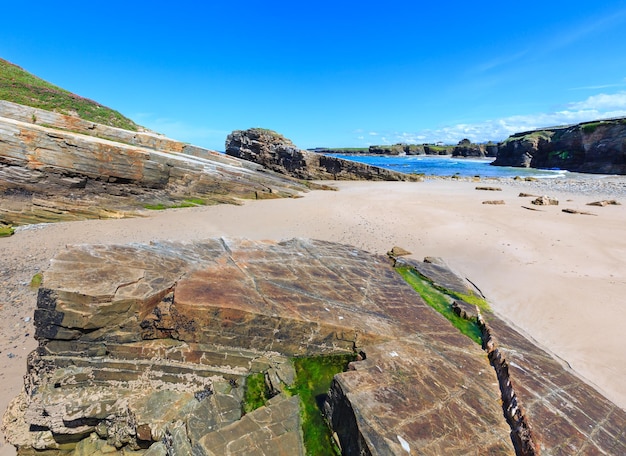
[0,59,138,131]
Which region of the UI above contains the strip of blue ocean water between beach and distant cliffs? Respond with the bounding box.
[332,154,567,179]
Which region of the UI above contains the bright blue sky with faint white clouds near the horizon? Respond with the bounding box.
[0,0,626,150]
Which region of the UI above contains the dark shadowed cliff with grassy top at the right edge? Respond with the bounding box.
[493,118,626,174]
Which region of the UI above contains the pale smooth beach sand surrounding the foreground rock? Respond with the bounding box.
[0,180,626,455]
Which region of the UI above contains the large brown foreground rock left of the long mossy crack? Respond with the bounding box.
[5,240,512,454]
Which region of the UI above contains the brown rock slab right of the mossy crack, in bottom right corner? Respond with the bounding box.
[398,258,626,455]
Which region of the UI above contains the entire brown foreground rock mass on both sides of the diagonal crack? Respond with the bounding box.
[3,239,626,455]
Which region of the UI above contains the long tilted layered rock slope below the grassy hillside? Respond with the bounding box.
[0,101,307,225]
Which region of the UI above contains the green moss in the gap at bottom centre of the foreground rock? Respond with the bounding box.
[290,354,355,456]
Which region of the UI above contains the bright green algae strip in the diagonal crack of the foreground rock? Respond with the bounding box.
[396,267,486,345]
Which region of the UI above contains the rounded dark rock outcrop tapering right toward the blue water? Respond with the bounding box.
[226,128,421,181]
